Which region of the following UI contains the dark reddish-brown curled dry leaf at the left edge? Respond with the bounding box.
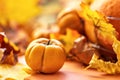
[0,32,20,65]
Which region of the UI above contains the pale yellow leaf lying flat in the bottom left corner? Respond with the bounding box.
[0,63,29,80]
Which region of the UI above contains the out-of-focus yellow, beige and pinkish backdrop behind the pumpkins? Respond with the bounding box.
[0,0,93,53]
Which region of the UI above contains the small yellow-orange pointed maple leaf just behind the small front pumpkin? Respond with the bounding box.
[50,28,80,53]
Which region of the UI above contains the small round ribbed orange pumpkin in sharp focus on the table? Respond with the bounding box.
[25,38,66,73]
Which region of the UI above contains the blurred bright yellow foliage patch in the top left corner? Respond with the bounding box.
[0,0,40,25]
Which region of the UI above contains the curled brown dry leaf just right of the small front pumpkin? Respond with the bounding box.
[70,36,98,65]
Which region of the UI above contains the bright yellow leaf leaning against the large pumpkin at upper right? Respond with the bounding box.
[80,3,116,39]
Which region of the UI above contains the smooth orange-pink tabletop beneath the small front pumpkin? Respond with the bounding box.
[19,58,120,80]
